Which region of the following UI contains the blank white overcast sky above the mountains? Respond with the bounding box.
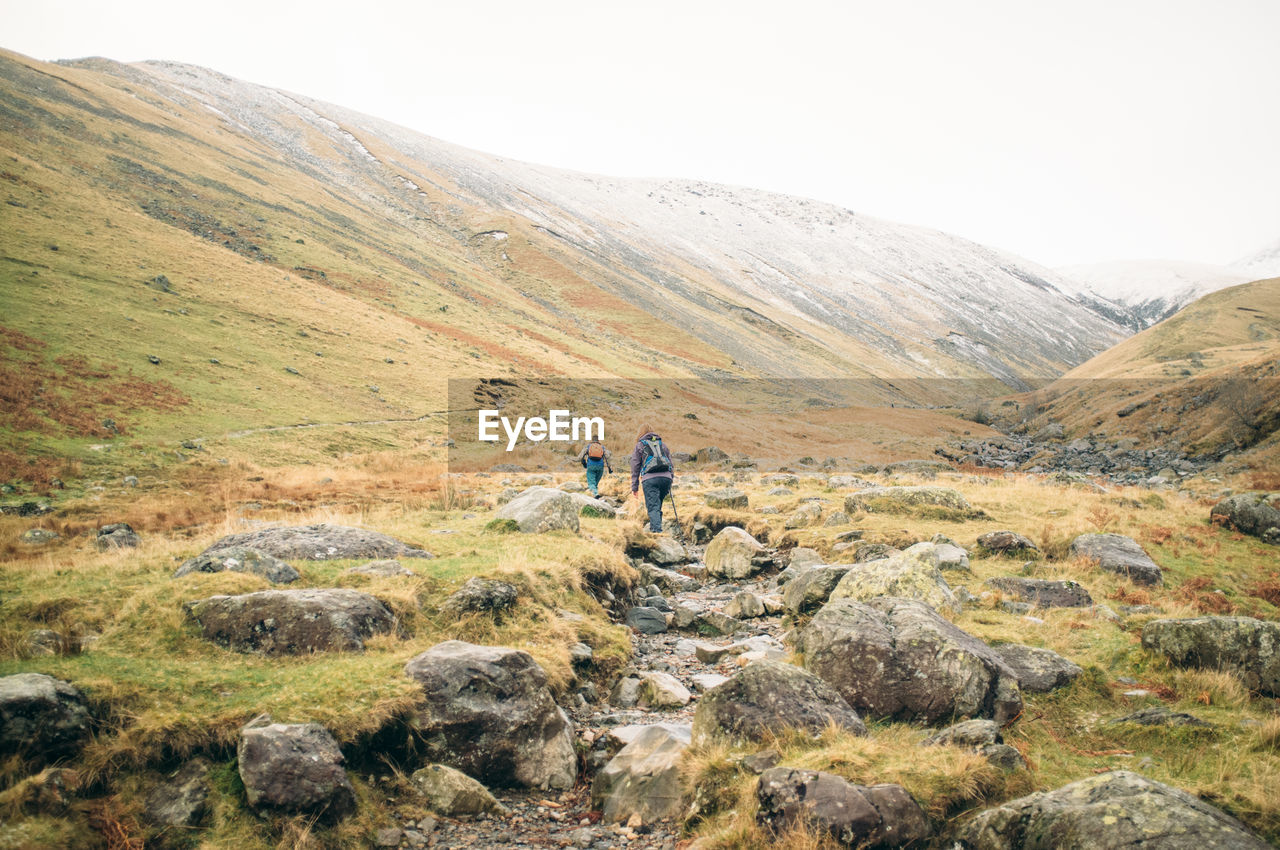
[0,0,1280,265]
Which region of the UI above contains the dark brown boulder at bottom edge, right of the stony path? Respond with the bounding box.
[755,767,929,847]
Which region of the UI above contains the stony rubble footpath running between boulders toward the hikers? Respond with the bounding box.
[398,547,785,850]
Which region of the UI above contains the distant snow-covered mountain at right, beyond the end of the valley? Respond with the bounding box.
[1059,260,1256,332]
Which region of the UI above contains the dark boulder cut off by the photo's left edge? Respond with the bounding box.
[0,673,91,767]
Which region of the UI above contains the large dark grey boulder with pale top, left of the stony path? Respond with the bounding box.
[404,640,577,790]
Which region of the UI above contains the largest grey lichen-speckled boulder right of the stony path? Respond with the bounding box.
[796,597,1023,723]
